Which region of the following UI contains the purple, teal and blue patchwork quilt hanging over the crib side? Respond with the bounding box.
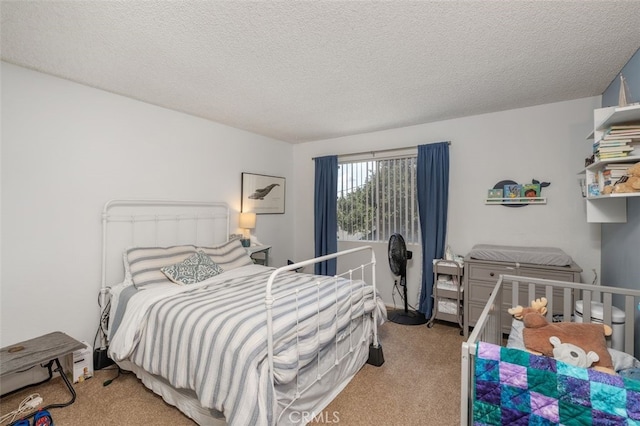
[473,342,640,426]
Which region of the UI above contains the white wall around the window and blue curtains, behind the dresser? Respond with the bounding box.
[293,97,600,310]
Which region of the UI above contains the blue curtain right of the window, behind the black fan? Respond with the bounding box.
[416,142,449,318]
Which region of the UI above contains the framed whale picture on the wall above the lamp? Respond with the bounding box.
[241,173,285,214]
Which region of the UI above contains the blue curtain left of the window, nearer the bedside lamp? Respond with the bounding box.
[314,155,338,276]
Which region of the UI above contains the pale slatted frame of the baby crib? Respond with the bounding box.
[460,275,640,426]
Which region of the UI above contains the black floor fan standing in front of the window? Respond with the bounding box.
[388,234,427,325]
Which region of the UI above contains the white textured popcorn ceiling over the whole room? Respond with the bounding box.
[1,0,640,143]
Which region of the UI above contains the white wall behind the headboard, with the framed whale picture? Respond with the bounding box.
[0,62,294,346]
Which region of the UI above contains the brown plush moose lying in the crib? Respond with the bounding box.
[508,298,615,374]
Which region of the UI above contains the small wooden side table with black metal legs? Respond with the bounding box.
[0,331,85,418]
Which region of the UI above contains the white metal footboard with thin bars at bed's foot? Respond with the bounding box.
[265,246,380,423]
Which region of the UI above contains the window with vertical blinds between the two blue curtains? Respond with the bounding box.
[338,155,420,243]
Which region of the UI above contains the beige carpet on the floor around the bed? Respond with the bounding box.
[0,322,463,426]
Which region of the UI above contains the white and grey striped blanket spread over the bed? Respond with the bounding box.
[109,265,386,425]
